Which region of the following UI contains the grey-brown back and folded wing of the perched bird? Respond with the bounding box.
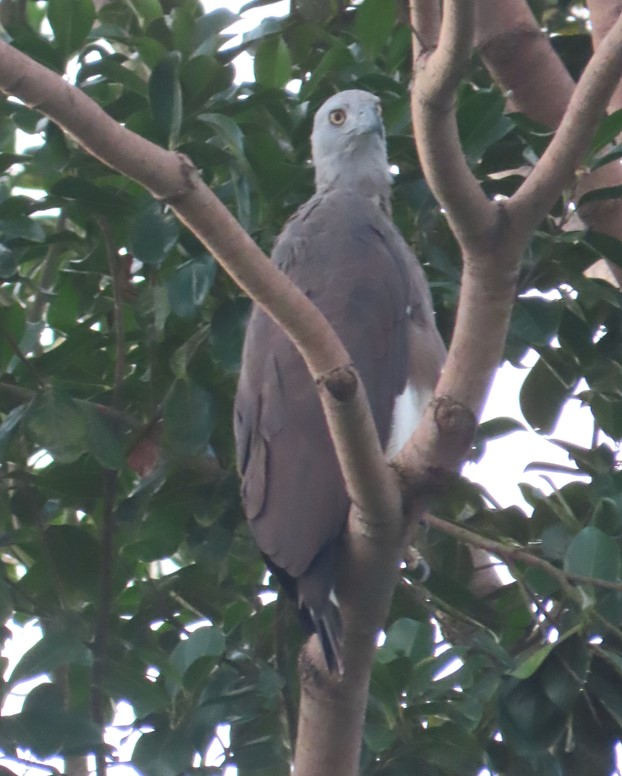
[235,191,444,605]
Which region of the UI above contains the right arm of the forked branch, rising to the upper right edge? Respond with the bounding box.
[507,12,622,232]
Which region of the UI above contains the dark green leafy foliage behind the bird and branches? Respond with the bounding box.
[0,0,622,776]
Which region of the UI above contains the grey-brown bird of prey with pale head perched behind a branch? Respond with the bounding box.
[234,89,445,674]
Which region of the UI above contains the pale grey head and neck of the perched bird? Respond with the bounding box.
[311,89,391,207]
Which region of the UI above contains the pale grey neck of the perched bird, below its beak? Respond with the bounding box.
[315,149,391,213]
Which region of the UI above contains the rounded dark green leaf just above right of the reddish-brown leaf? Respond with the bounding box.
[164,379,213,456]
